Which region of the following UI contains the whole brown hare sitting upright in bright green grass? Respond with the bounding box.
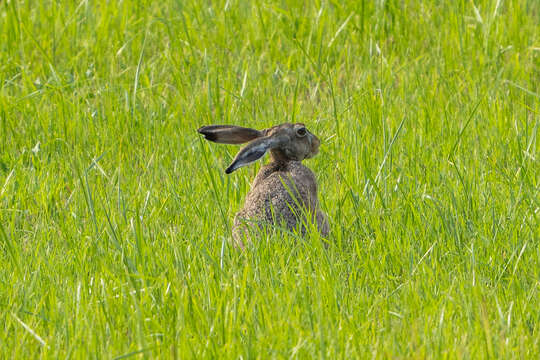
[198,123,330,248]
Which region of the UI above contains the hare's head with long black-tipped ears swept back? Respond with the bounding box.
[198,123,320,174]
